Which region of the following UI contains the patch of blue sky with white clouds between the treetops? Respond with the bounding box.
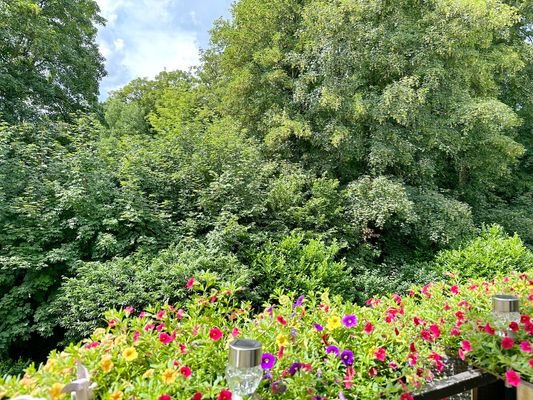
[96,0,233,99]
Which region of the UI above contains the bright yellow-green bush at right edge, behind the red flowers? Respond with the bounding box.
[436,225,533,278]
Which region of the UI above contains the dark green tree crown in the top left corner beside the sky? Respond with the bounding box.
[0,0,105,122]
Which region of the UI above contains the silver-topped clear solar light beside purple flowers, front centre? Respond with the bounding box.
[226,339,263,400]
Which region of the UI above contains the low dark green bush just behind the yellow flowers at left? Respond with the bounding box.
[51,241,250,340]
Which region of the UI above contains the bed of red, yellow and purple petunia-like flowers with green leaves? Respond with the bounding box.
[0,274,533,400]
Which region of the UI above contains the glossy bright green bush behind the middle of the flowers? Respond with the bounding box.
[251,233,353,300]
